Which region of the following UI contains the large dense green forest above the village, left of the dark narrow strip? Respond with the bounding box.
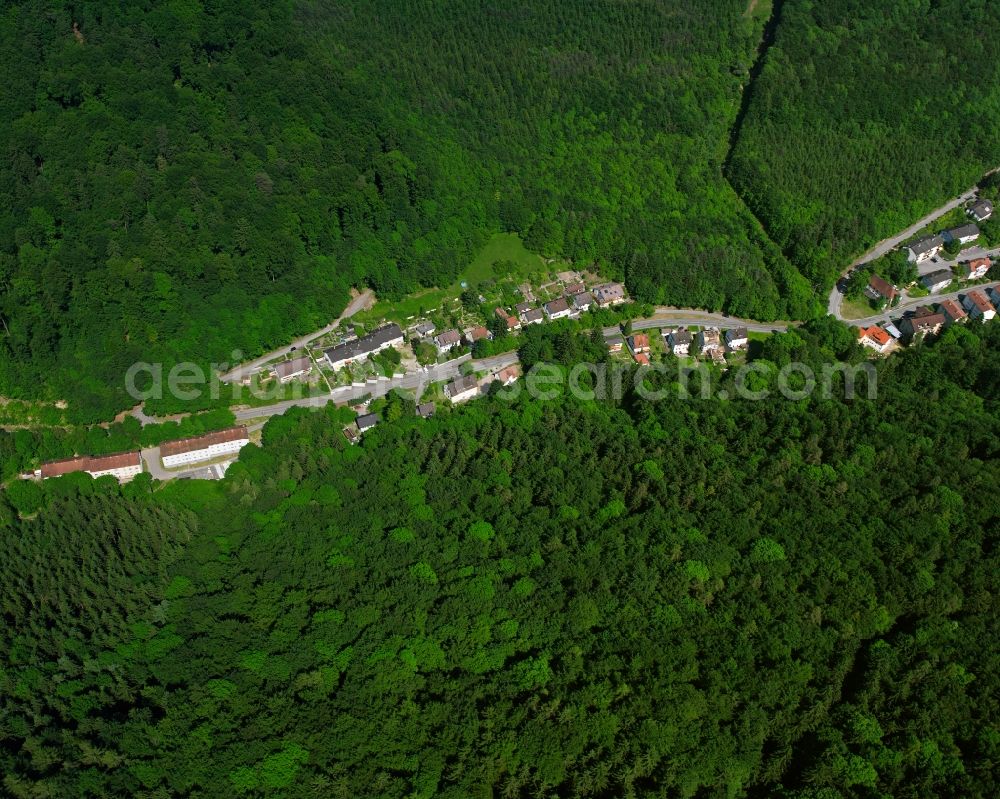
[0,0,812,421]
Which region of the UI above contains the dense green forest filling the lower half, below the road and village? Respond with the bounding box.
[0,323,1000,799]
